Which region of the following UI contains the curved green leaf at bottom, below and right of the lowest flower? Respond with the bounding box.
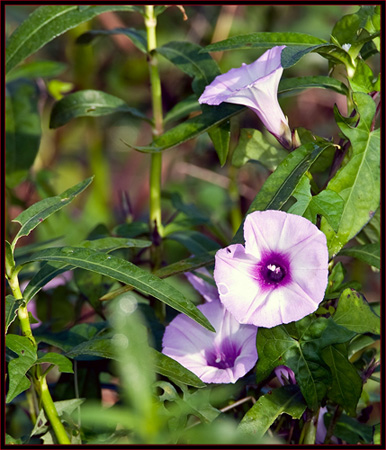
[238,385,306,439]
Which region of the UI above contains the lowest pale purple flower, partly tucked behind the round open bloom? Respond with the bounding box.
[162,299,257,383]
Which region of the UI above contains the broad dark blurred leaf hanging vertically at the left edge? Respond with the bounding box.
[5,79,41,188]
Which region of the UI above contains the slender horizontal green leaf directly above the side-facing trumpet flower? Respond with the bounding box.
[202,32,327,52]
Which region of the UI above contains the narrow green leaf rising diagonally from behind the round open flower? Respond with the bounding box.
[232,142,330,242]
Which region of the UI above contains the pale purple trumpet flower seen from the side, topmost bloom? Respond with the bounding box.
[198,45,293,149]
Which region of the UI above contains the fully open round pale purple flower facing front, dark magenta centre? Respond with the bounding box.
[214,210,328,328]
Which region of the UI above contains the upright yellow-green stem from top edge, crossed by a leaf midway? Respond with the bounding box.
[145,5,163,241]
